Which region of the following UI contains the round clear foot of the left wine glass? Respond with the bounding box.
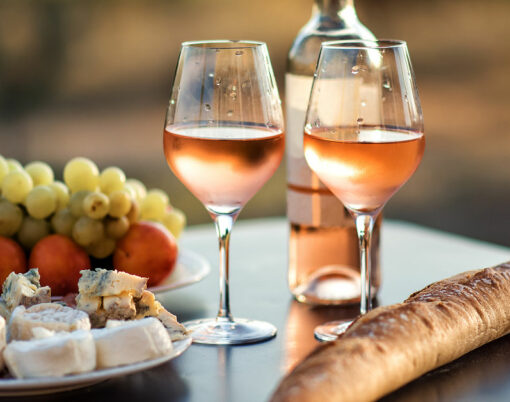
[184,318,276,345]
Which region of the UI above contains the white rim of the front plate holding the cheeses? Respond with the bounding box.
[0,337,191,396]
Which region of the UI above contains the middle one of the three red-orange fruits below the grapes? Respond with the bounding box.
[28,234,90,296]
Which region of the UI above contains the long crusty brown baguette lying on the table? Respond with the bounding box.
[271,262,510,402]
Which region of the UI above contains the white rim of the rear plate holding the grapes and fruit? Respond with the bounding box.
[148,249,211,293]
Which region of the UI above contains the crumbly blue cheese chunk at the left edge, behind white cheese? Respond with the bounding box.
[2,268,51,311]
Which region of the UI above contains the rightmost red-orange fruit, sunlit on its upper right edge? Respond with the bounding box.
[113,221,177,286]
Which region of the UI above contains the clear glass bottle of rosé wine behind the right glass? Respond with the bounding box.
[285,0,381,305]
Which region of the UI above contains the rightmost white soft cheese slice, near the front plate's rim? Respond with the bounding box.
[92,318,172,368]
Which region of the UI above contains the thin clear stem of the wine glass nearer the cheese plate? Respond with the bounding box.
[213,214,237,322]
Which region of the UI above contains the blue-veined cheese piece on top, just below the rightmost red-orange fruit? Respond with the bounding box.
[78,268,147,297]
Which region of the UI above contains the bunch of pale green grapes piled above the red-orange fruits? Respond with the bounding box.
[0,155,186,258]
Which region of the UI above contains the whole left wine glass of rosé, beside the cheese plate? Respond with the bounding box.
[163,40,285,345]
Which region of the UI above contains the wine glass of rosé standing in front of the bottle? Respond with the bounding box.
[303,40,425,341]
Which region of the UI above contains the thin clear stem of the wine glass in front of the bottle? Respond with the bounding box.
[354,213,375,314]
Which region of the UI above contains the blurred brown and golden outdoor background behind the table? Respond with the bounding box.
[0,0,510,246]
